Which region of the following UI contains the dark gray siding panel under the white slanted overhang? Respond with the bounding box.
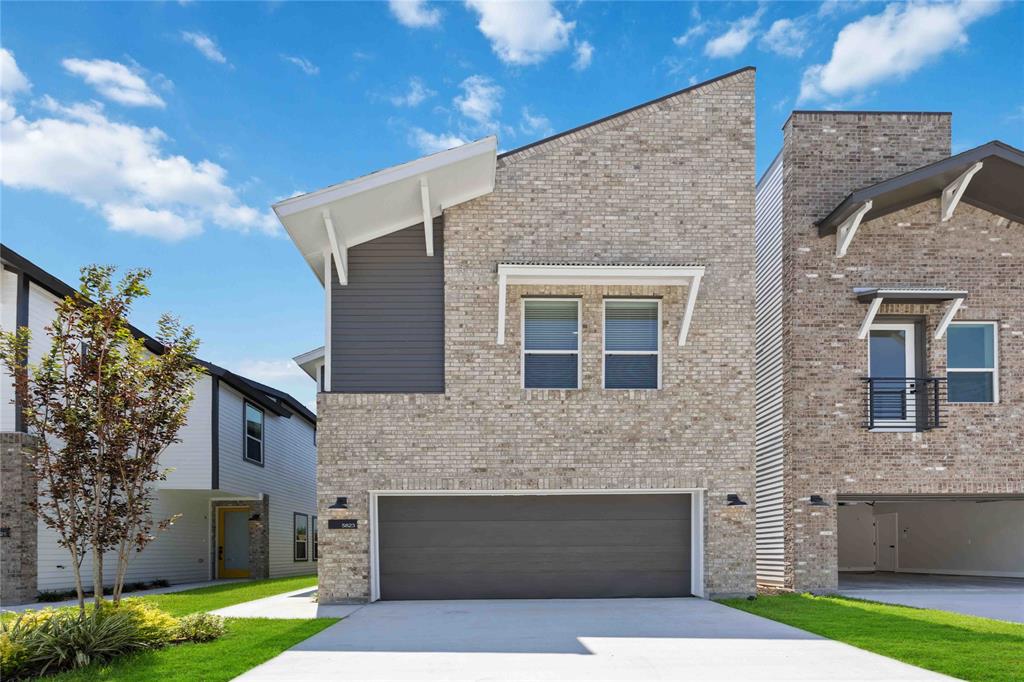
[331,218,444,393]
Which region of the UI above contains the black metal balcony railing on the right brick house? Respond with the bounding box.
[861,377,946,431]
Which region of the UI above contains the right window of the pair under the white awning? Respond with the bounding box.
[604,299,662,388]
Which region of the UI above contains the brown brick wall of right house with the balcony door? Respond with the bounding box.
[783,114,1024,590]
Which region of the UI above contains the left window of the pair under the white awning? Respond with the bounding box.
[522,298,580,388]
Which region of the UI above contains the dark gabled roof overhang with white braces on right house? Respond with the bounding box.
[818,141,1024,257]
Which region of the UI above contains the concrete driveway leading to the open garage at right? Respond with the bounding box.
[839,573,1024,623]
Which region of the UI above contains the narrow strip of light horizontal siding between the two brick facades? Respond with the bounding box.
[755,154,785,585]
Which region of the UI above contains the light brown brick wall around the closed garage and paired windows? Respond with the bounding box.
[317,71,754,601]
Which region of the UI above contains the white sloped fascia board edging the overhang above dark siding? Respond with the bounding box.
[272,135,498,218]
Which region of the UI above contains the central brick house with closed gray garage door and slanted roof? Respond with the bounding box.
[274,69,755,602]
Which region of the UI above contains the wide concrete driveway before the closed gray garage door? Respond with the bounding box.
[239,599,948,682]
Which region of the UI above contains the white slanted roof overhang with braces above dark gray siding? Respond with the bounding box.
[273,136,498,284]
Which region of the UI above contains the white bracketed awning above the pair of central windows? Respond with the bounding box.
[498,262,705,346]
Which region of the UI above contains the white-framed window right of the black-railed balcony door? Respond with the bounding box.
[946,322,999,402]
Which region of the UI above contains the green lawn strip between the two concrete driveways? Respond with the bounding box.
[722,594,1024,682]
